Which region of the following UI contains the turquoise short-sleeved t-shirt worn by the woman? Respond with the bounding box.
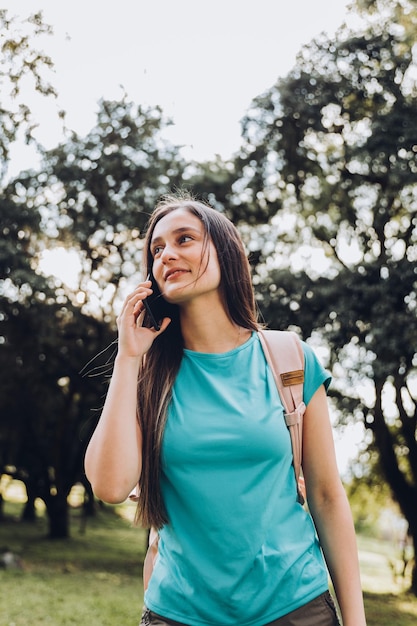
[145,333,330,626]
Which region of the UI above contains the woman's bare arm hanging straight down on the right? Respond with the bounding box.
[303,385,366,626]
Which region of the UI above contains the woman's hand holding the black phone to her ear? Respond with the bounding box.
[117,280,171,358]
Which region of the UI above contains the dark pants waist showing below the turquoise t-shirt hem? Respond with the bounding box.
[139,591,340,626]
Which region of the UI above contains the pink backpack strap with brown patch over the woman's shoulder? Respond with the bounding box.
[258,330,306,504]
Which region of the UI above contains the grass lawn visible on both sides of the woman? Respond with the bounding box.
[0,482,417,626]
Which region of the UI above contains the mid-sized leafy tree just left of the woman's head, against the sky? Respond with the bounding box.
[21,96,185,322]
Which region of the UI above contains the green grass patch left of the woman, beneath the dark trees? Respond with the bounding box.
[0,492,146,626]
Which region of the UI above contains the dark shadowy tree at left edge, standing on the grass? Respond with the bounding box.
[0,184,112,538]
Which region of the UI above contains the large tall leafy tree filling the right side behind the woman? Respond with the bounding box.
[235,2,417,594]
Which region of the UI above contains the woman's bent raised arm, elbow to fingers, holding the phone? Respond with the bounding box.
[85,281,170,504]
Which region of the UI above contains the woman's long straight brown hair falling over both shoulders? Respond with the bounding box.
[136,194,259,528]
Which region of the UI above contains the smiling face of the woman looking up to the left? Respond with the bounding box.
[150,208,221,304]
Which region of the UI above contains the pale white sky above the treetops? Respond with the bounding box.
[6,0,350,168]
